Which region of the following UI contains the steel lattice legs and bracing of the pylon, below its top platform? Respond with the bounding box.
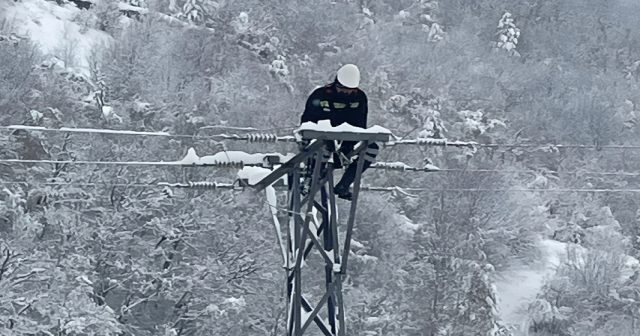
[287,143,366,336]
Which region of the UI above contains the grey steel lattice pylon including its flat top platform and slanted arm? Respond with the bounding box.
[254,130,389,336]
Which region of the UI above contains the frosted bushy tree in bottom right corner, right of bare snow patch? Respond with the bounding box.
[530,207,638,335]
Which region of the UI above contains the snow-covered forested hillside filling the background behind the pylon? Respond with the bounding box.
[0,0,640,336]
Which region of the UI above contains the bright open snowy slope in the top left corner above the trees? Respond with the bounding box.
[0,0,111,76]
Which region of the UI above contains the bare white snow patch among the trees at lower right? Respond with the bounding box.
[496,240,567,335]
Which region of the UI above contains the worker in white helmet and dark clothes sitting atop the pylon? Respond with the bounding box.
[301,64,380,201]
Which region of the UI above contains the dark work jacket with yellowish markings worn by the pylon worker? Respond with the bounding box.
[300,84,368,128]
